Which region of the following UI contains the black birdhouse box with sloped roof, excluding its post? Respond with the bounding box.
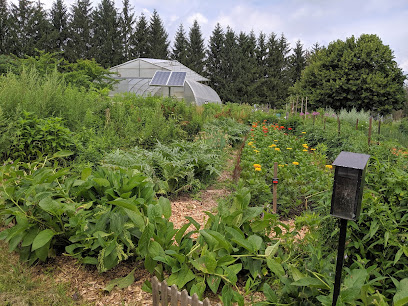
[330,152,370,221]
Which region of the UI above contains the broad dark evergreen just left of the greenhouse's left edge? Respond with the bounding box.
[91,0,124,68]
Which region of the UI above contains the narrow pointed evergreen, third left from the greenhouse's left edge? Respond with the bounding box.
[50,0,69,52]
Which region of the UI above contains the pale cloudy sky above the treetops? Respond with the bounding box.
[12,0,408,74]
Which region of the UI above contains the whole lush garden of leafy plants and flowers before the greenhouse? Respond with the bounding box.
[0,63,408,305]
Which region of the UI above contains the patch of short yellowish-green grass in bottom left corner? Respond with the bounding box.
[0,241,77,305]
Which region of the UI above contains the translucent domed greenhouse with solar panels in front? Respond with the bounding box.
[110,58,221,105]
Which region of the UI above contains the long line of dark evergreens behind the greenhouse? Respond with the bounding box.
[0,0,306,104]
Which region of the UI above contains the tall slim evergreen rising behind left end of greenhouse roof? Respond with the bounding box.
[120,0,136,61]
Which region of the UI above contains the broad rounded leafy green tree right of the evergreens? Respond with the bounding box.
[296,34,406,114]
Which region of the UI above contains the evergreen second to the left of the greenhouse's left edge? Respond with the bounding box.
[65,0,92,62]
